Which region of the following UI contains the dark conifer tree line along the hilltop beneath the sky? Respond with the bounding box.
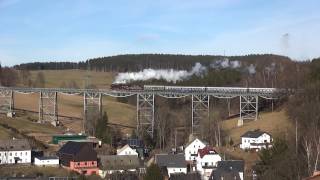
[14,54,290,72]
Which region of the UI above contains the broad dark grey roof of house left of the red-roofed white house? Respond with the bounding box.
[155,154,187,167]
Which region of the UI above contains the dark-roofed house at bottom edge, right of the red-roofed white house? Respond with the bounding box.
[209,160,244,180]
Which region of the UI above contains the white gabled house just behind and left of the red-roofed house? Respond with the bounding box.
[184,138,206,161]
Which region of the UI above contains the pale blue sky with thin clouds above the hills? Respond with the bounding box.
[0,0,320,65]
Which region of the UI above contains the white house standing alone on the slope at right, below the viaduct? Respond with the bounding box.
[240,129,272,151]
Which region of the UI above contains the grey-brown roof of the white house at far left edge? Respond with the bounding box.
[0,139,31,151]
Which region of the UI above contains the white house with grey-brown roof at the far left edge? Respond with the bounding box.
[0,139,31,164]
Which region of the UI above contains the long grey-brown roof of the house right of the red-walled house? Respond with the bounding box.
[98,155,143,170]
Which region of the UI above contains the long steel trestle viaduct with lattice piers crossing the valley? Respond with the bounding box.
[0,86,287,137]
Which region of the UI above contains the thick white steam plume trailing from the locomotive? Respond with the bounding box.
[114,63,207,84]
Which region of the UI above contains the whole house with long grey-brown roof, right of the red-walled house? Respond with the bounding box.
[98,155,145,178]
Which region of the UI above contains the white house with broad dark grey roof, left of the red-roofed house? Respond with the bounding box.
[155,154,187,177]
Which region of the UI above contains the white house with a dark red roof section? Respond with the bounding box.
[196,146,221,180]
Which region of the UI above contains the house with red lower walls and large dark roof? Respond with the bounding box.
[57,141,99,175]
